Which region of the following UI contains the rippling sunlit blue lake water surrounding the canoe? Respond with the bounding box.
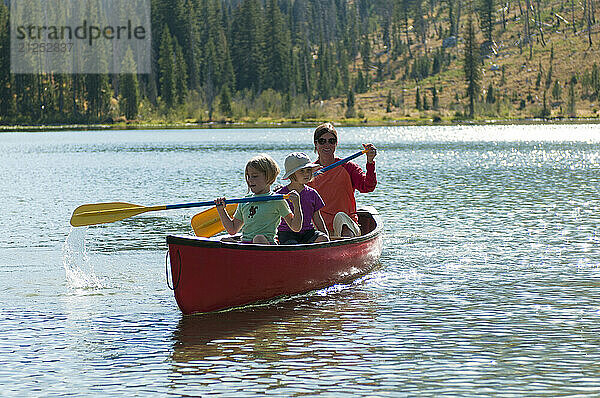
[0,125,600,397]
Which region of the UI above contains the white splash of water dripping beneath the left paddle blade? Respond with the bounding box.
[63,227,103,289]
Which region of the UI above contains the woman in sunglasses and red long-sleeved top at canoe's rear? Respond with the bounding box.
[307,123,377,236]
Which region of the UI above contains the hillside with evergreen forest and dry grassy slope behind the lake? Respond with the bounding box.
[0,0,600,124]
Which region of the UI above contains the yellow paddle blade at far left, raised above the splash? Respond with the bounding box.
[71,202,166,227]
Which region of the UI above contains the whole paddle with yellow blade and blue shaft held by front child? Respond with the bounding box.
[71,195,288,227]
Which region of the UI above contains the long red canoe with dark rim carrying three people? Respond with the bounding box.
[167,206,382,314]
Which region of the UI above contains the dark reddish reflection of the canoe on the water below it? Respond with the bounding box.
[172,286,376,366]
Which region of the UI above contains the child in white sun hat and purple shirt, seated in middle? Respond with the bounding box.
[277,152,329,245]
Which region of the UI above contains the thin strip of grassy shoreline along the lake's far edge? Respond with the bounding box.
[0,117,600,132]
